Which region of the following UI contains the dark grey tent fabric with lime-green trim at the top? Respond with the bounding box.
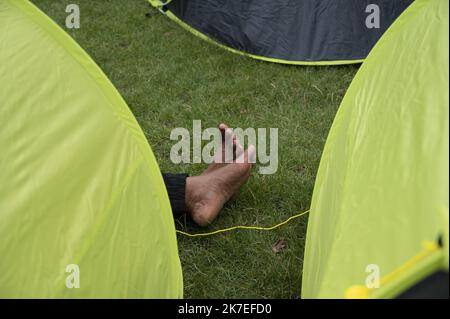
[149,0,412,65]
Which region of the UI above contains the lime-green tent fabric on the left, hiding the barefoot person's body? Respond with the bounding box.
[0,0,183,298]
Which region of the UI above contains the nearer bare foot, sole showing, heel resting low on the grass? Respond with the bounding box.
[186,144,255,227]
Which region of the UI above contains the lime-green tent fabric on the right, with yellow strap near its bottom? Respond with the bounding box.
[302,0,449,298]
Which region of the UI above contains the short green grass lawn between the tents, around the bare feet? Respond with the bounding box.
[33,0,357,298]
